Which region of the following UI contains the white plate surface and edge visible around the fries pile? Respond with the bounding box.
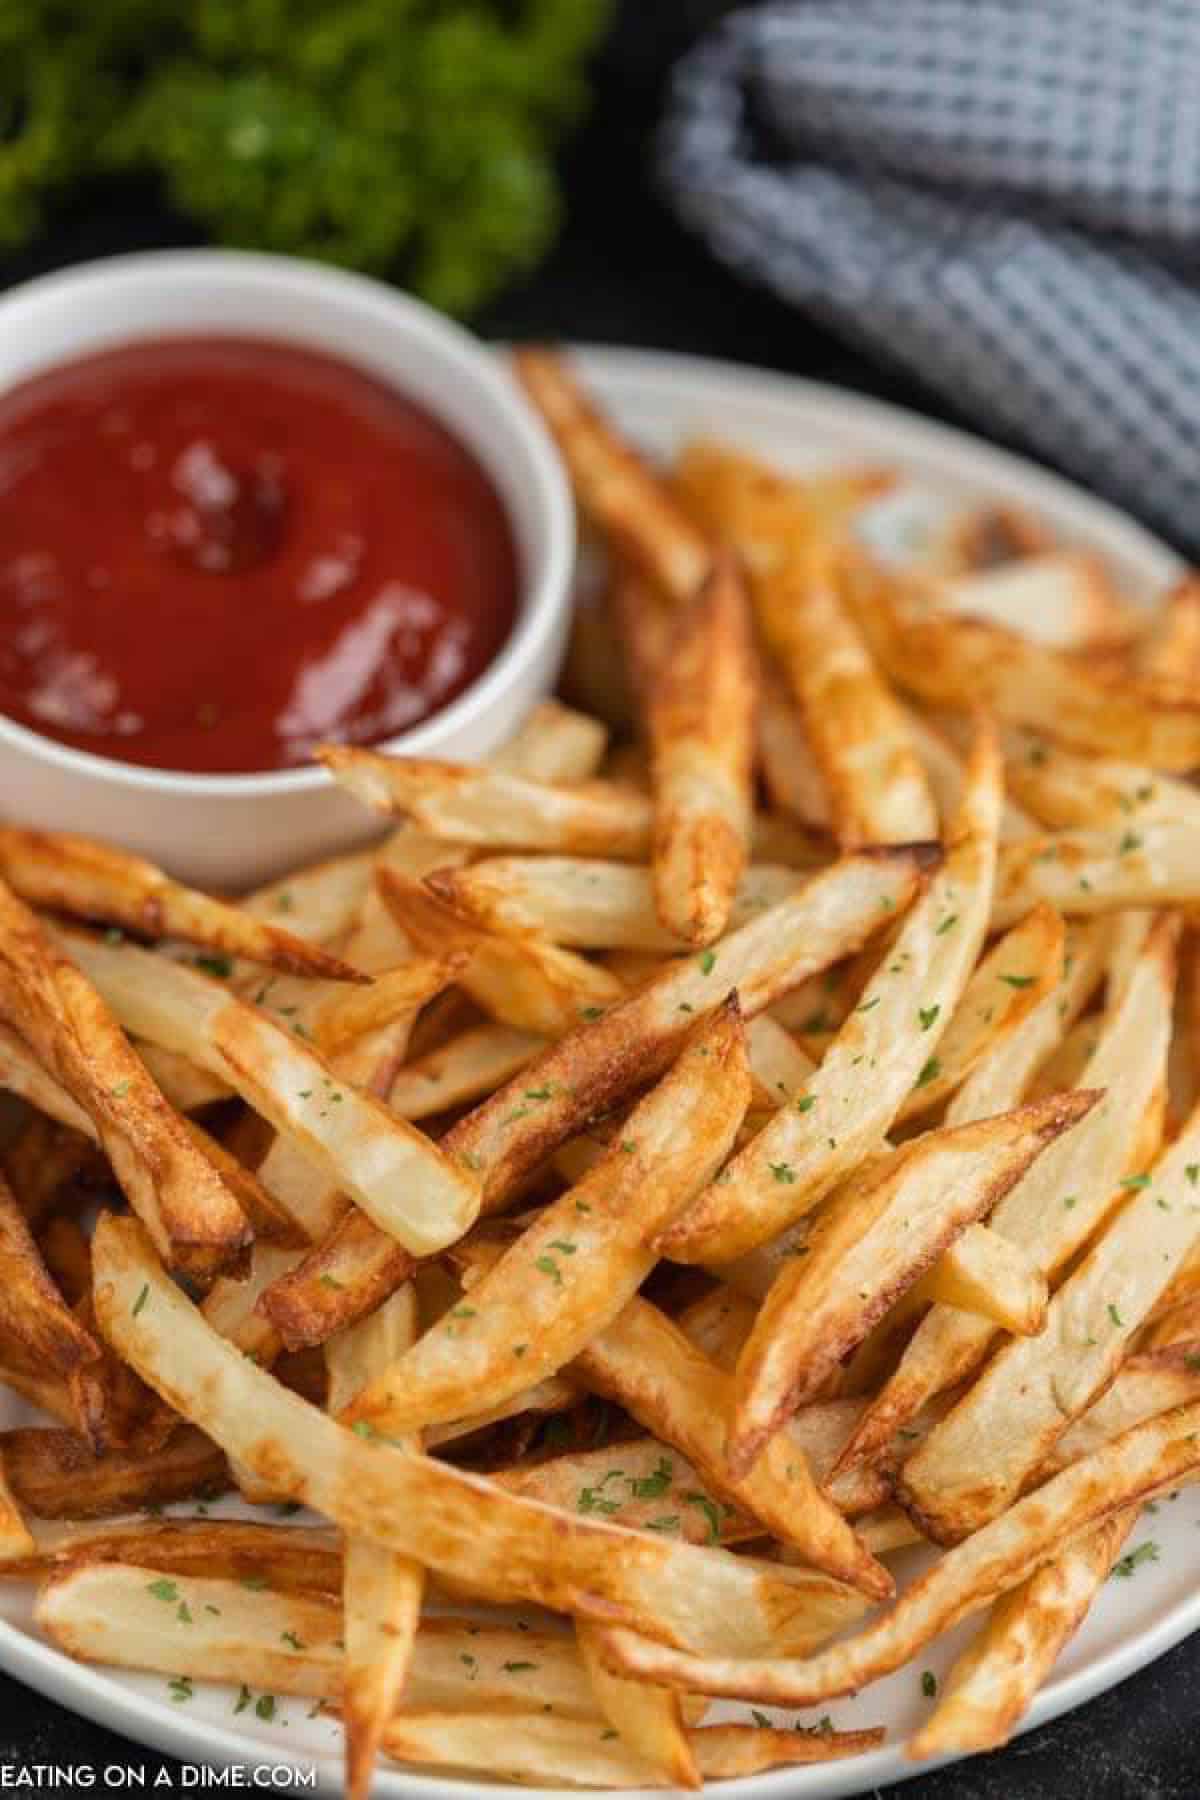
[0,349,1200,1800]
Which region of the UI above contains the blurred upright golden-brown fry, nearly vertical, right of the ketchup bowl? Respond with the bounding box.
[646,553,755,945]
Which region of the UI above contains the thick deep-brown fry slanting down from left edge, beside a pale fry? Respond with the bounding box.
[0,882,250,1274]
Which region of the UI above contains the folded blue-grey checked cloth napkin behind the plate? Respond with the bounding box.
[660,0,1200,553]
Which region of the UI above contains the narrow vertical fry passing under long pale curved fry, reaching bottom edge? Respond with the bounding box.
[326,1287,425,1800]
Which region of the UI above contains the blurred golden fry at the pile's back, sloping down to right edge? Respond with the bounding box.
[847,554,1200,774]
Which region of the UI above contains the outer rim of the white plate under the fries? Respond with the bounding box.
[0,342,1200,1800]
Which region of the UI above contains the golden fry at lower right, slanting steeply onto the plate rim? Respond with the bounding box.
[907,1507,1137,1760]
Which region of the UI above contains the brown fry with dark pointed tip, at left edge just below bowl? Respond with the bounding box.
[0,824,362,981]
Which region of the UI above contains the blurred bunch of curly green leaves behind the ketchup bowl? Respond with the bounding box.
[0,0,608,313]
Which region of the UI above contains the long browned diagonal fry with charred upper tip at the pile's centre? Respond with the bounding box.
[263,850,930,1343]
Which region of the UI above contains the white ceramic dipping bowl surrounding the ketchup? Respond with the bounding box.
[0,250,574,891]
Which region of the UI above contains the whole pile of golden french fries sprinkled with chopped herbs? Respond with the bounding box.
[0,351,1200,1800]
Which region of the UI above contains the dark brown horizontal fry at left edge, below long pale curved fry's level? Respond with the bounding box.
[0,1427,228,1519]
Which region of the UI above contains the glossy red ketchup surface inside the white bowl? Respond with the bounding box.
[0,338,518,772]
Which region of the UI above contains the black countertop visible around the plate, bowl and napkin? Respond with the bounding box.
[0,0,1200,1800]
